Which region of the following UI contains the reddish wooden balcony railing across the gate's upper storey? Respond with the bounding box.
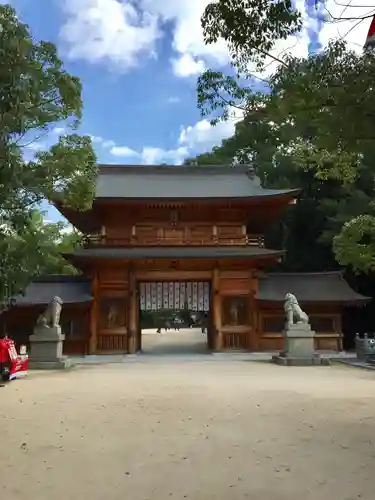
[84,235,264,248]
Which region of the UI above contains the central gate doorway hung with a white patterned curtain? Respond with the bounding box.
[137,281,213,354]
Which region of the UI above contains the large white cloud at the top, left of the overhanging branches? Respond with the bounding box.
[60,0,229,76]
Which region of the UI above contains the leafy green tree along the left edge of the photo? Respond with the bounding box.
[0,5,96,305]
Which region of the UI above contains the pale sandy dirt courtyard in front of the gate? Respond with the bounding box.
[0,356,375,500]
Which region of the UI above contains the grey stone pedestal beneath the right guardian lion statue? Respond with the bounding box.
[272,323,330,366]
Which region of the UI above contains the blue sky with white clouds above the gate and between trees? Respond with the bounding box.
[0,0,374,223]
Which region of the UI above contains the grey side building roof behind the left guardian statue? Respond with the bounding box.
[10,275,93,307]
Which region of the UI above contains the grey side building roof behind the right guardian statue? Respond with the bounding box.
[255,271,371,305]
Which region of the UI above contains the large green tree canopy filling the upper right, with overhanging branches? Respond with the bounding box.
[197,0,375,272]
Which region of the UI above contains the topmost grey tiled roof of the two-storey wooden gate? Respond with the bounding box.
[95,165,299,200]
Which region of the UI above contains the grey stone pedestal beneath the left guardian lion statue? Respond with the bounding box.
[29,326,71,370]
